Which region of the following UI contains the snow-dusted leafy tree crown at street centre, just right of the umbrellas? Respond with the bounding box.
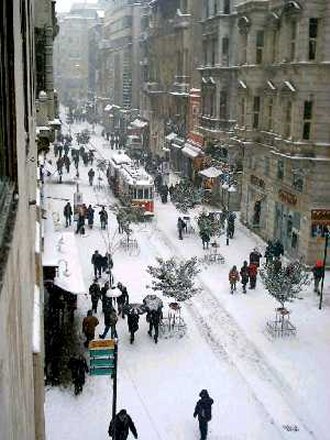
[147,257,200,301]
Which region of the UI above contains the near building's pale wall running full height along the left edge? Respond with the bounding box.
[0,0,50,440]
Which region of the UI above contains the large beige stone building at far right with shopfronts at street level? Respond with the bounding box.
[232,0,330,264]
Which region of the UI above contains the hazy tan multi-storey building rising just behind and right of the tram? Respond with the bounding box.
[142,0,201,160]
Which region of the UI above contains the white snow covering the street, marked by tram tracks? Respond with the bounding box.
[44,121,330,440]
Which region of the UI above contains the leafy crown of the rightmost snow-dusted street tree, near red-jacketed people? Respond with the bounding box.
[260,260,311,307]
